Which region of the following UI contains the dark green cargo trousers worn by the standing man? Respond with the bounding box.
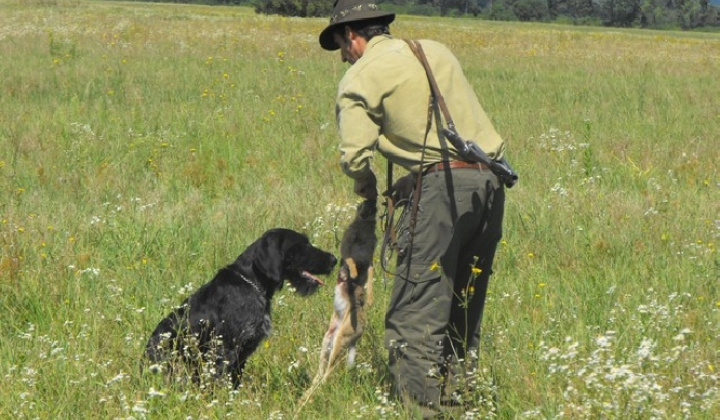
[385,169,505,417]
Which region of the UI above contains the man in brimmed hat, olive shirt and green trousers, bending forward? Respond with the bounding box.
[319,0,505,417]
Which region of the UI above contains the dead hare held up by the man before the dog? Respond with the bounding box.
[304,200,377,402]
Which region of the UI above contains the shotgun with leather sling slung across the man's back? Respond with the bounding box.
[405,40,518,188]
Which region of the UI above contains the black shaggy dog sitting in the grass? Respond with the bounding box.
[145,229,337,387]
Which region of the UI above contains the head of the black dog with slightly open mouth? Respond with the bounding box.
[252,229,337,296]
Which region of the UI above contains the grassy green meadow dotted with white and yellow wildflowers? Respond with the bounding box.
[0,0,720,420]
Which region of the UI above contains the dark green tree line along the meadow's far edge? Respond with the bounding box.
[115,0,720,30]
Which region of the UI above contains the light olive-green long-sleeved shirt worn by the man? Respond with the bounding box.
[336,36,504,178]
